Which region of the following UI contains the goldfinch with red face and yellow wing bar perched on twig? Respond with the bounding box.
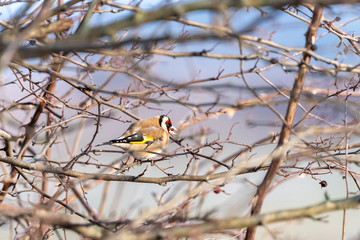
[97,115,177,160]
